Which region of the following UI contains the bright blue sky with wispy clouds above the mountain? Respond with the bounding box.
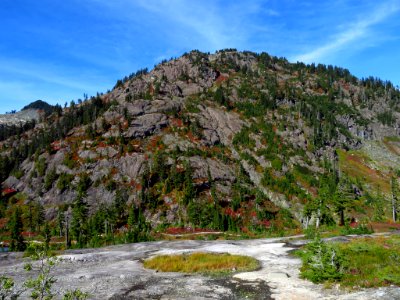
[0,0,400,113]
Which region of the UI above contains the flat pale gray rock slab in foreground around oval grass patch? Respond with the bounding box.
[0,238,400,300]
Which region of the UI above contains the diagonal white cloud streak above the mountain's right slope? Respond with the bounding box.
[292,1,400,63]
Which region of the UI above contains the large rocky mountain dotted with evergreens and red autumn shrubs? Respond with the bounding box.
[0,49,400,245]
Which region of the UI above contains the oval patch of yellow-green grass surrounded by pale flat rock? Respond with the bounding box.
[143,252,260,275]
